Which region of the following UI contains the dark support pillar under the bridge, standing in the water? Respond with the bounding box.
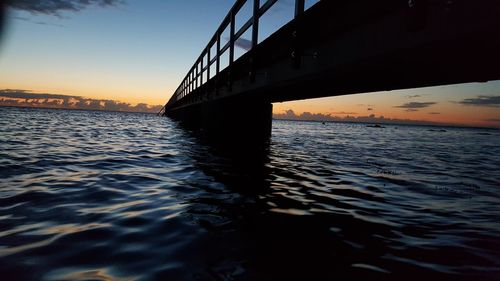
[167,97,273,146]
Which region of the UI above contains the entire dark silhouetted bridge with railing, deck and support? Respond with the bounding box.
[159,0,500,138]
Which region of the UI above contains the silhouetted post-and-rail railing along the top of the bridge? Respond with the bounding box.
[166,0,305,111]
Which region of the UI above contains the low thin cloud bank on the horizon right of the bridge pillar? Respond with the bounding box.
[273,109,438,125]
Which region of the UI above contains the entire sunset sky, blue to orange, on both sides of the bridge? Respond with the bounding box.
[0,0,500,127]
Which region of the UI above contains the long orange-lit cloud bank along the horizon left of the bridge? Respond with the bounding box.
[0,89,162,113]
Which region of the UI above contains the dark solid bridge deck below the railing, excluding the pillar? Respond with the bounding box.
[166,0,500,112]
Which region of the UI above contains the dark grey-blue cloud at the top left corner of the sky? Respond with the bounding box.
[7,0,123,16]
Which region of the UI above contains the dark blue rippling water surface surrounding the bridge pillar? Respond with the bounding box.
[0,108,500,280]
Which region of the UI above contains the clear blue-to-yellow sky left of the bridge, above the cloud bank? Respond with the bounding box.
[0,0,238,103]
